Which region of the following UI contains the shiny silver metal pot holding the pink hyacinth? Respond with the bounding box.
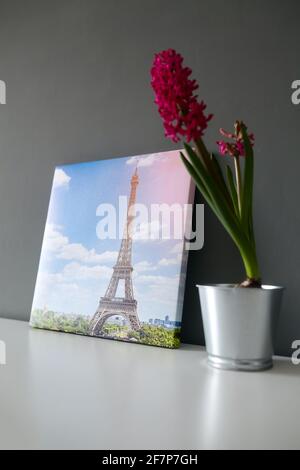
[197,284,284,371]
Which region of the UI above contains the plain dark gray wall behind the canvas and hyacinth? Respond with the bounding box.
[0,0,300,354]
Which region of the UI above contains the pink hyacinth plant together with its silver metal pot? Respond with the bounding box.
[151,49,283,370]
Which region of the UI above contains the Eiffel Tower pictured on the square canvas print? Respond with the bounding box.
[90,167,141,336]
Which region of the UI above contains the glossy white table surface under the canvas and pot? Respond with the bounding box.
[0,319,300,450]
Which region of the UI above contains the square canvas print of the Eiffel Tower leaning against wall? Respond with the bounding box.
[30,151,194,348]
